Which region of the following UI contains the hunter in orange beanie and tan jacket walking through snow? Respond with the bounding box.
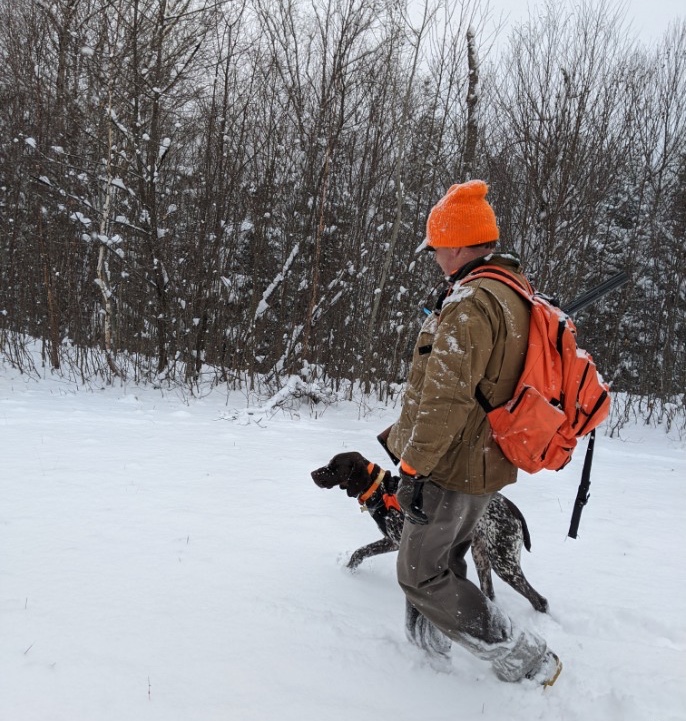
[387,180,561,685]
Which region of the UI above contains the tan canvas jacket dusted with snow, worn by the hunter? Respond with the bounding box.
[388,254,529,494]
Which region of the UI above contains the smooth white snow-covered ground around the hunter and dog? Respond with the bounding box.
[0,366,686,721]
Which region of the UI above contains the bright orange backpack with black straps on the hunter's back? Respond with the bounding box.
[460,265,610,473]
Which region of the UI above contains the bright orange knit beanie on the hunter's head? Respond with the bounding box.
[425,180,500,248]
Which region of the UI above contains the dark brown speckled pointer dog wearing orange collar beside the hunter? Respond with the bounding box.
[311,451,548,612]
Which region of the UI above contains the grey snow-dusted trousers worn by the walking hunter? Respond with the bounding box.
[397,481,547,681]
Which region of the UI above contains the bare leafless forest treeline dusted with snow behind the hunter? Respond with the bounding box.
[0,0,686,424]
